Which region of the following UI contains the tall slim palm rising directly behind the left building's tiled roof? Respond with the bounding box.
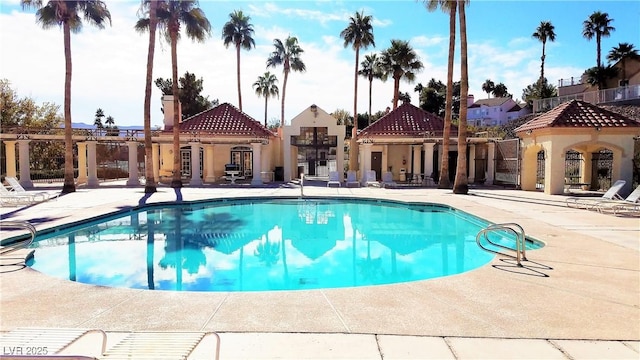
[222,10,256,111]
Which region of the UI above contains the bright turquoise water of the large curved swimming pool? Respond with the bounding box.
[28,198,540,291]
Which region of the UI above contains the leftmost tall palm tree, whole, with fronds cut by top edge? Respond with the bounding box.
[20,0,111,194]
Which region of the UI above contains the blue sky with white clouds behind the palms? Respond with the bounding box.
[0,0,640,127]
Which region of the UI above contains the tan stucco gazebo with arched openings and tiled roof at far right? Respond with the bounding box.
[515,100,640,194]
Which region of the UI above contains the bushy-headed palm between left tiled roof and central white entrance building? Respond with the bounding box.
[267,36,307,127]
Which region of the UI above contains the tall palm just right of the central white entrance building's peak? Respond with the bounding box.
[340,12,376,134]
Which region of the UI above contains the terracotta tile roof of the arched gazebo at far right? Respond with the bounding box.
[515,100,640,132]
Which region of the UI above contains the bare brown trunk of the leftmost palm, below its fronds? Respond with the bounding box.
[62,21,76,194]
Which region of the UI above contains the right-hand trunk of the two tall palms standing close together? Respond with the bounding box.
[453,1,469,194]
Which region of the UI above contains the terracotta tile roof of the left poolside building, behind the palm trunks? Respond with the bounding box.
[180,103,274,137]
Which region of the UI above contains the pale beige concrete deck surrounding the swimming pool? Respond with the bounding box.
[0,181,640,359]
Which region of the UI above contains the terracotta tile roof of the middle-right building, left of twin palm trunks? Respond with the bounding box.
[358,103,458,138]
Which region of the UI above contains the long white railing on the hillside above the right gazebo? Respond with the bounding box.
[533,85,640,112]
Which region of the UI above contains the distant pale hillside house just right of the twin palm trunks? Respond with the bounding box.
[467,96,531,126]
